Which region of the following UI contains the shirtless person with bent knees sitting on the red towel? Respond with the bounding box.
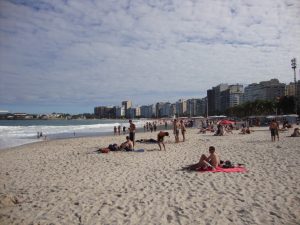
[184,146,220,170]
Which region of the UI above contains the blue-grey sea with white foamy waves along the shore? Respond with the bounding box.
[0,119,146,149]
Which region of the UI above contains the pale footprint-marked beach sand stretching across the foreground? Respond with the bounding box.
[0,127,300,225]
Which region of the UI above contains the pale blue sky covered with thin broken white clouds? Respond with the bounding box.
[0,0,300,114]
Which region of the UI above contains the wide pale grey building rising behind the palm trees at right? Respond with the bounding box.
[244,79,286,102]
